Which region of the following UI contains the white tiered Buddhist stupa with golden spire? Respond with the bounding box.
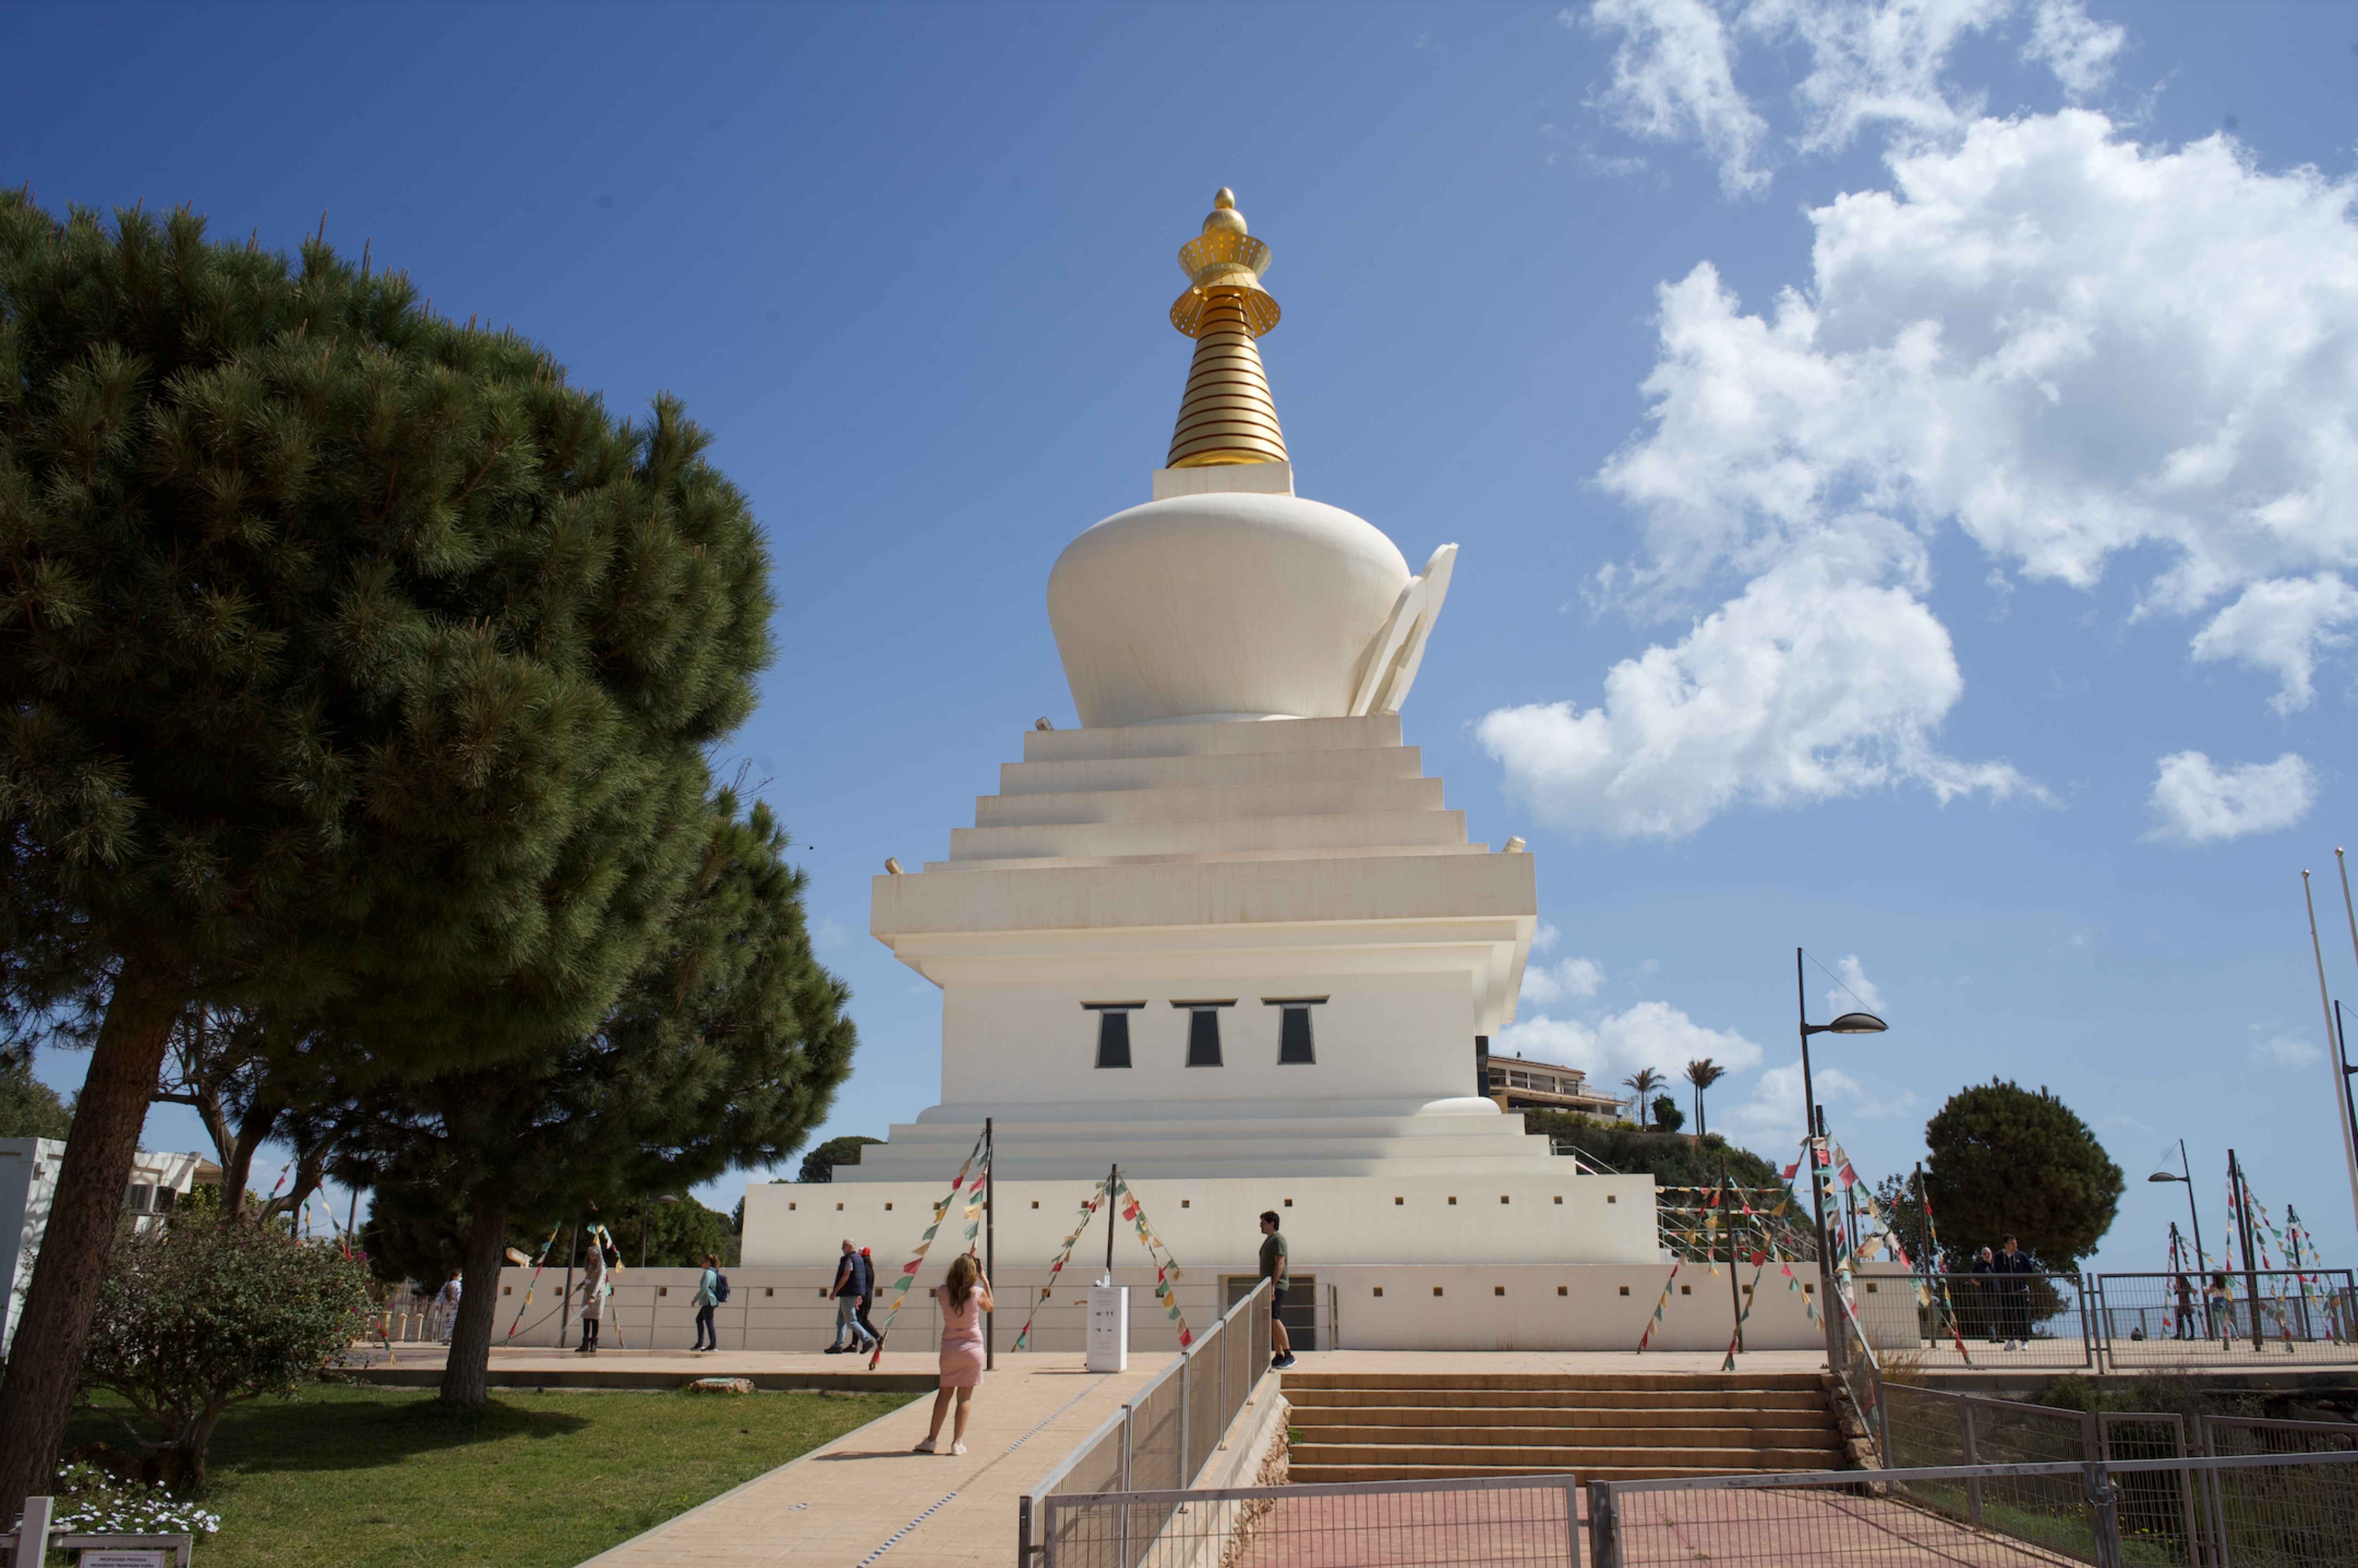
[745,191,1806,1346]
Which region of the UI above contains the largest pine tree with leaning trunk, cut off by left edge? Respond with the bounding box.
[0,193,771,1514]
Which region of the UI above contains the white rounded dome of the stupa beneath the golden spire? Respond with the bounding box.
[1047,490,1410,729]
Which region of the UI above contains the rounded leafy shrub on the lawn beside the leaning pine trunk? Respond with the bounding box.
[83,1212,368,1483]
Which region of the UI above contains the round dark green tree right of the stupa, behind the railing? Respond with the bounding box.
[1924,1078,2122,1273]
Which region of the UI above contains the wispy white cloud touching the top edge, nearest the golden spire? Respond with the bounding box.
[1556,0,1768,196]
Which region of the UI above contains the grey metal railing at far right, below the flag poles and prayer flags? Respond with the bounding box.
[2094,1269,2358,1368]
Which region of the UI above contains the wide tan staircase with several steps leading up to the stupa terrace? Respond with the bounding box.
[1285,1372,1842,1485]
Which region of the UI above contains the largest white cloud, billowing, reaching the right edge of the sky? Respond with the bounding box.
[1601,111,2358,613]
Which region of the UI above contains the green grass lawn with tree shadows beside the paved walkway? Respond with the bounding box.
[66,1386,915,1568]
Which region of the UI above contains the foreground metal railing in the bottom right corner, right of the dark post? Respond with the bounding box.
[1585,1452,2358,1568]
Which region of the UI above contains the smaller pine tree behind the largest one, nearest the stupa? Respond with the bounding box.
[361,792,856,1405]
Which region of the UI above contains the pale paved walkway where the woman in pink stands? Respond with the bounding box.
[585,1351,1167,1568]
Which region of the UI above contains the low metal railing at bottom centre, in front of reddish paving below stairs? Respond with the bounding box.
[1040,1474,1580,1568]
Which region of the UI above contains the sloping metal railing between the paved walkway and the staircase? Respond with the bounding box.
[1016,1280,1269,1568]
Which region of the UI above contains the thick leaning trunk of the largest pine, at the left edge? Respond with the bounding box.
[0,957,186,1518]
